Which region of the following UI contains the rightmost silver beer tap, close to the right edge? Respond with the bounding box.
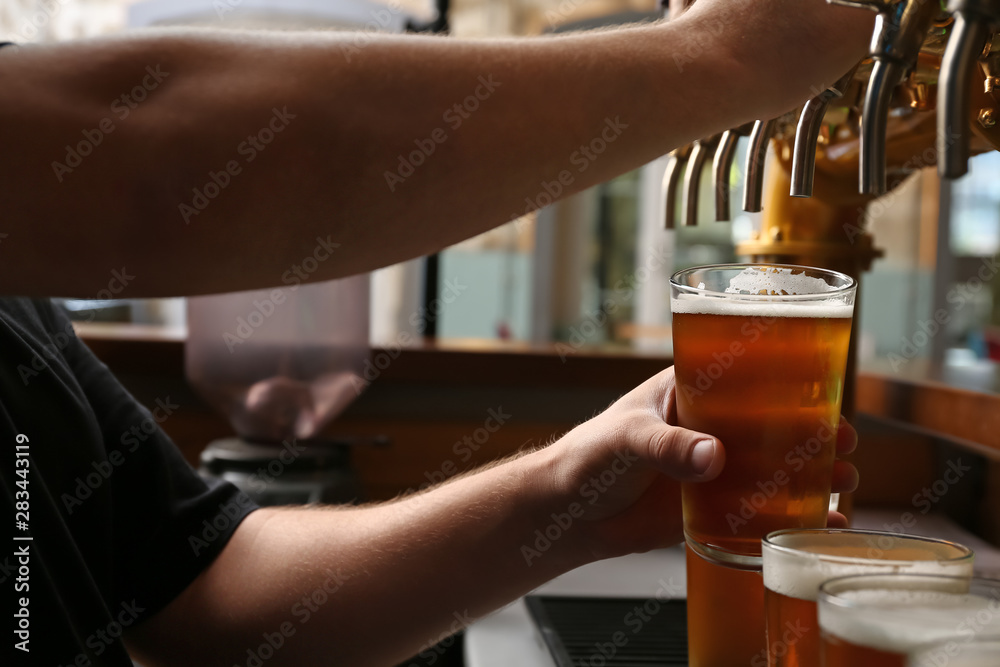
[937,0,1000,178]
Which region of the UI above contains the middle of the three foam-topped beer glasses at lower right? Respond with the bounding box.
[819,573,1000,667]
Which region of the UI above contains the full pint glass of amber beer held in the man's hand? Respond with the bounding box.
[670,264,856,571]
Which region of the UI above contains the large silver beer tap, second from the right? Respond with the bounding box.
[827,0,941,195]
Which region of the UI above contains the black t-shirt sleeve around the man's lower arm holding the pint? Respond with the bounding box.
[37,302,256,617]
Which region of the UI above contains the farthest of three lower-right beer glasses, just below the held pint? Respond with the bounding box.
[762,529,973,667]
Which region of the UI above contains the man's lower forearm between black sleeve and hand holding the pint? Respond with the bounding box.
[131,444,586,667]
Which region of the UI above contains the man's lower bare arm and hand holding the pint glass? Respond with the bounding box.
[127,369,857,667]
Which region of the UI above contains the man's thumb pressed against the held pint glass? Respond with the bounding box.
[632,420,726,482]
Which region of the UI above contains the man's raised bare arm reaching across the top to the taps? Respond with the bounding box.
[0,0,870,297]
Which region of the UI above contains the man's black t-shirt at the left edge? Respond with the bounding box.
[0,299,255,667]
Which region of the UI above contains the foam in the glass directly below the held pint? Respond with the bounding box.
[763,533,973,602]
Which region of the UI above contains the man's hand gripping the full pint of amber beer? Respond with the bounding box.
[549,368,858,558]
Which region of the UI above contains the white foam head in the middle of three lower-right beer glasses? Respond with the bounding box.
[819,589,1000,653]
